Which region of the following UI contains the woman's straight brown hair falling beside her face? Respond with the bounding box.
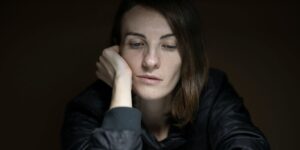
[111,0,208,127]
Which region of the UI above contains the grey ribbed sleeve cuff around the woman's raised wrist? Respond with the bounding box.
[102,107,142,130]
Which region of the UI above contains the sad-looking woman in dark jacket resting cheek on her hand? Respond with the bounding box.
[62,0,269,150]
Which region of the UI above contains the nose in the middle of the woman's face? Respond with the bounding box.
[142,49,160,71]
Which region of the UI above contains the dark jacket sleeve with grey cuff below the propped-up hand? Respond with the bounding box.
[61,82,142,150]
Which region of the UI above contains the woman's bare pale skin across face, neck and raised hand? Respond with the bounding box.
[96,6,182,141]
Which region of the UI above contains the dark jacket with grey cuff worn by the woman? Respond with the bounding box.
[62,69,270,150]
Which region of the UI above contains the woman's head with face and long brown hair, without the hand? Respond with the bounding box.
[112,0,208,126]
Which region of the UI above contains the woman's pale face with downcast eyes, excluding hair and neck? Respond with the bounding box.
[121,6,181,100]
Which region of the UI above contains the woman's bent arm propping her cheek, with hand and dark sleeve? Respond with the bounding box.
[62,46,142,150]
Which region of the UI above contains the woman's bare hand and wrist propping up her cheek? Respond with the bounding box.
[96,46,132,108]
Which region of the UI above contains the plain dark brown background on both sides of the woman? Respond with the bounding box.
[0,0,300,150]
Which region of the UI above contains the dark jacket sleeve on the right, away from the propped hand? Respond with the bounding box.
[208,71,270,150]
